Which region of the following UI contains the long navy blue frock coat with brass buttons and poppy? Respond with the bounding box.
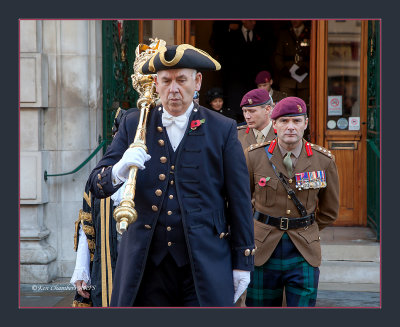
[89,104,254,307]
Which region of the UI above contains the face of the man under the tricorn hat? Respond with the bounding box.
[155,68,202,116]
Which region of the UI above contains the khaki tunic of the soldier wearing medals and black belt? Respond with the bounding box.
[245,139,339,267]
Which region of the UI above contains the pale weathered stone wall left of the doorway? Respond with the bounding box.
[20,20,102,283]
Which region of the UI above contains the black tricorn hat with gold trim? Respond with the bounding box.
[139,44,221,75]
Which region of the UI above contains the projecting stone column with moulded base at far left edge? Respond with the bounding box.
[20,20,57,283]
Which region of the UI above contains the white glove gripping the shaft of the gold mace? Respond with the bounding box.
[112,147,151,182]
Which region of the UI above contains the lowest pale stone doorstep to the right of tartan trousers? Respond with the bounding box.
[319,260,380,284]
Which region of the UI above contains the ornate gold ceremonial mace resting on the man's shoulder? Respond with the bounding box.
[113,38,166,234]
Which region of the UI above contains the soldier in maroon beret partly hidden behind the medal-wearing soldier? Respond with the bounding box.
[237,89,275,150]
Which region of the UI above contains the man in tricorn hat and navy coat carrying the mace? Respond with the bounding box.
[90,44,255,307]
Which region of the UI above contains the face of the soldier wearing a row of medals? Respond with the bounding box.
[272,116,308,148]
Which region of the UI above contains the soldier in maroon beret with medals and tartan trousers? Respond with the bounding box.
[245,97,339,307]
